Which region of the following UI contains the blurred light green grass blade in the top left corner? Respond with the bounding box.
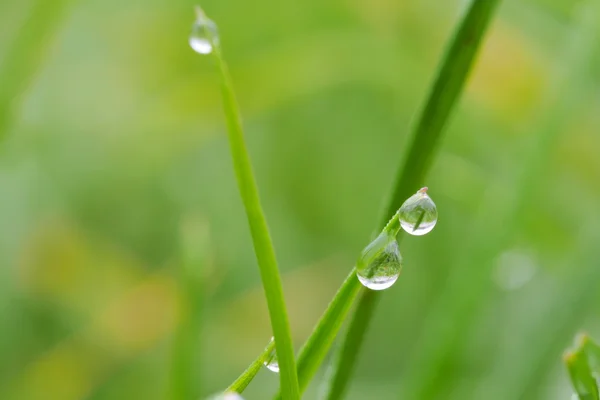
[0,0,70,139]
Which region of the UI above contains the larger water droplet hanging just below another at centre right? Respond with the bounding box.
[356,231,402,290]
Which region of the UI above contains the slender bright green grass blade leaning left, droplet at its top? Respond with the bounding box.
[198,9,300,400]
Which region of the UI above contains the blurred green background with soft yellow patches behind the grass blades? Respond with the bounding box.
[0,0,600,400]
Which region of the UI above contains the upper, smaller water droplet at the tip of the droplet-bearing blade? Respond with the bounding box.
[398,187,437,236]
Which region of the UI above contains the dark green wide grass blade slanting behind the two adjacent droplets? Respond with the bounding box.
[326,0,499,400]
